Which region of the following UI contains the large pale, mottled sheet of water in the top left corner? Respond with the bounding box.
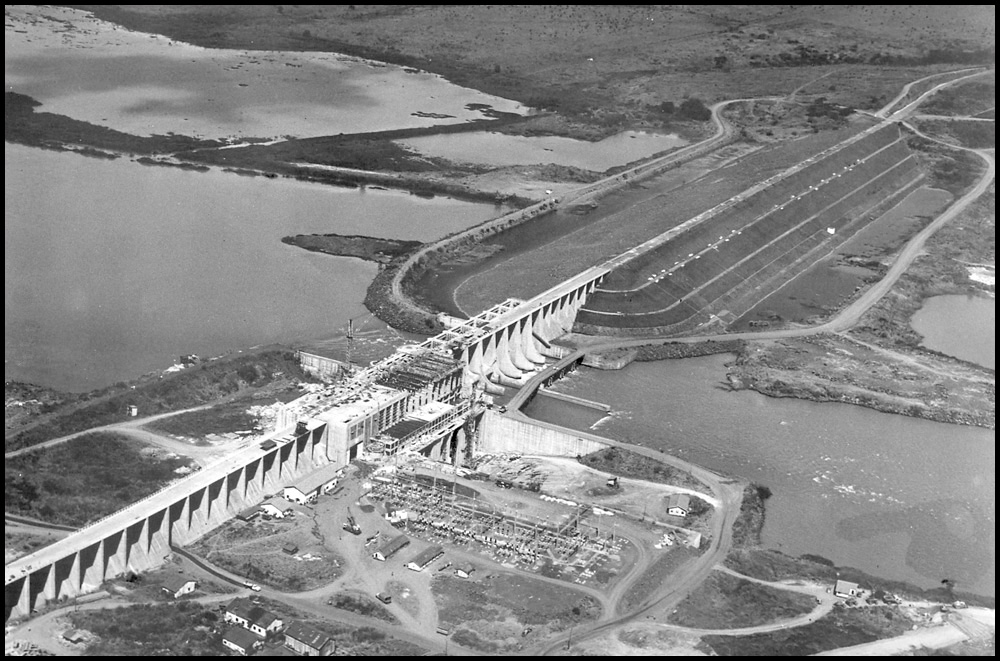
[4,6,528,138]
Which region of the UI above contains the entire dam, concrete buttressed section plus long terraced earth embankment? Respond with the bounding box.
[4,112,919,620]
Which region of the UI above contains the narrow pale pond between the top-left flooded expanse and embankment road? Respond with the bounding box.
[399,131,687,172]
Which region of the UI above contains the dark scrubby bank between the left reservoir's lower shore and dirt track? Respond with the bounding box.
[4,346,312,452]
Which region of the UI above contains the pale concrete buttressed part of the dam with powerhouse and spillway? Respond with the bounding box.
[4,269,604,621]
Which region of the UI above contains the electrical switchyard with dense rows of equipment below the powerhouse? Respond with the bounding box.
[358,454,701,587]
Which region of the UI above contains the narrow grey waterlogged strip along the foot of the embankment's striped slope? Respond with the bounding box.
[733,188,952,330]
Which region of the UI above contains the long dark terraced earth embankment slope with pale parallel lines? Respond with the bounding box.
[575,124,923,335]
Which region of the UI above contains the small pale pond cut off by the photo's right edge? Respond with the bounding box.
[910,294,997,369]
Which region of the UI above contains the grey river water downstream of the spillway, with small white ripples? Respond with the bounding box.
[527,356,996,595]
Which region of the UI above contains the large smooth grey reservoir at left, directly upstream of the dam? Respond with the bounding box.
[4,144,502,391]
